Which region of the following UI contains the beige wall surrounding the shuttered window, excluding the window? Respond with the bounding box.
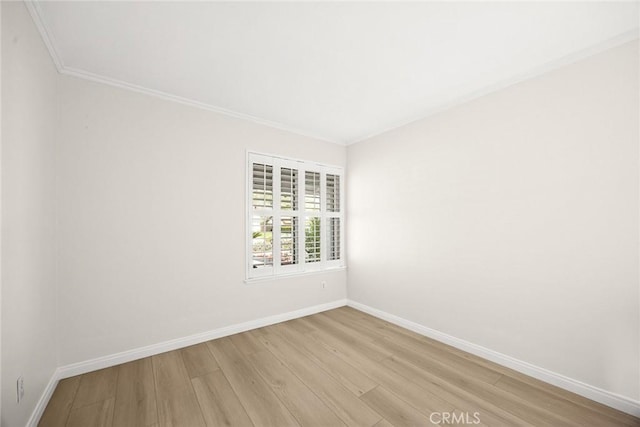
[57,73,346,365]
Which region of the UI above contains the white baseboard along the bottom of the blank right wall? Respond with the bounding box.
[347,300,640,417]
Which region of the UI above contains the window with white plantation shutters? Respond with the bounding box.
[247,153,344,279]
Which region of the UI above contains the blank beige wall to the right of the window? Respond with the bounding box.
[347,42,640,400]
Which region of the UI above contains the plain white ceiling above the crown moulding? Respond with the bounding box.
[31,1,639,143]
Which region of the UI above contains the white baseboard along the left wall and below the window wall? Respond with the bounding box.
[27,299,347,427]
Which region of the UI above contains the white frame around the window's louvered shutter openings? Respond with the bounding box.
[245,151,345,282]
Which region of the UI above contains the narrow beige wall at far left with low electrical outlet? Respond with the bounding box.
[1,2,58,427]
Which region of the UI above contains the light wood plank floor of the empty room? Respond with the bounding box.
[40,307,640,427]
